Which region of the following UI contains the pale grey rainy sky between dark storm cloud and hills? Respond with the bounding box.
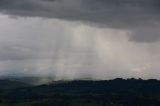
[0,15,160,79]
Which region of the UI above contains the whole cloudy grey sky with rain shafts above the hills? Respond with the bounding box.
[0,0,160,79]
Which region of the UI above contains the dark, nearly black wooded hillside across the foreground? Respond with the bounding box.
[0,78,160,106]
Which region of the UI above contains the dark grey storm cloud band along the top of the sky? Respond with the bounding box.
[0,0,160,42]
